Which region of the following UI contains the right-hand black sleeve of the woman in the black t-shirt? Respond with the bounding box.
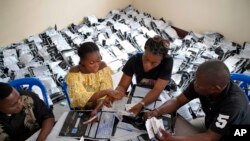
[159,57,174,80]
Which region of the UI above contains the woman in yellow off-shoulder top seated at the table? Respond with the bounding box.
[66,42,121,109]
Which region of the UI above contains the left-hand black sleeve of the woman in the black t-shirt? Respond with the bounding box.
[122,55,136,77]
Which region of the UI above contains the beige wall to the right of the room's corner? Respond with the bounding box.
[132,0,250,44]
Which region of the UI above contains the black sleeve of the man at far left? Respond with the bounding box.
[30,92,54,126]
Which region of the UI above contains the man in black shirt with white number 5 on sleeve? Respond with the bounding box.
[145,60,250,141]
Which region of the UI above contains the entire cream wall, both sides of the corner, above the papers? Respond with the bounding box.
[0,0,250,47]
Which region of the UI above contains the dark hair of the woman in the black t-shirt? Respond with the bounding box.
[144,35,169,57]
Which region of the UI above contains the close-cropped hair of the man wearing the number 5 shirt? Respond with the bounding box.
[196,60,230,87]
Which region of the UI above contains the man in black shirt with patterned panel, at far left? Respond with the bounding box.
[0,82,55,141]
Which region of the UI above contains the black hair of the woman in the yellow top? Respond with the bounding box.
[78,42,99,59]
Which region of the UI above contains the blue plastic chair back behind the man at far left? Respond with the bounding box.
[9,77,50,108]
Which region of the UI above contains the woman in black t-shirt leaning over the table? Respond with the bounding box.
[104,35,173,115]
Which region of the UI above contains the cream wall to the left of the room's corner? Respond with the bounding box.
[0,0,132,47]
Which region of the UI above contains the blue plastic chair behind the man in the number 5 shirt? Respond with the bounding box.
[231,73,250,101]
